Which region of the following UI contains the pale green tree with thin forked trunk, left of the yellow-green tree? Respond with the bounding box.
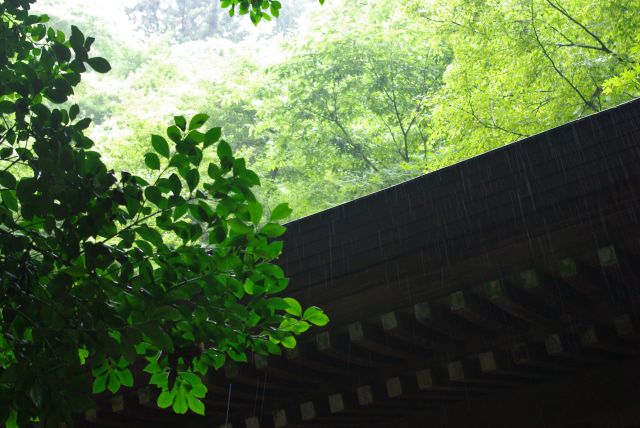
[238,0,449,212]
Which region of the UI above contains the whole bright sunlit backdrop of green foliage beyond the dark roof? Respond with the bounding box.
[33,0,640,217]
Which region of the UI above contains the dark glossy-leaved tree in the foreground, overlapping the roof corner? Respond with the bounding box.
[0,0,328,426]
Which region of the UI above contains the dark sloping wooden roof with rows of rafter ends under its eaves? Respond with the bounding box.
[82,100,640,428]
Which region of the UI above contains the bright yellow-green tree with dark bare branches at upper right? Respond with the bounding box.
[406,0,640,169]
